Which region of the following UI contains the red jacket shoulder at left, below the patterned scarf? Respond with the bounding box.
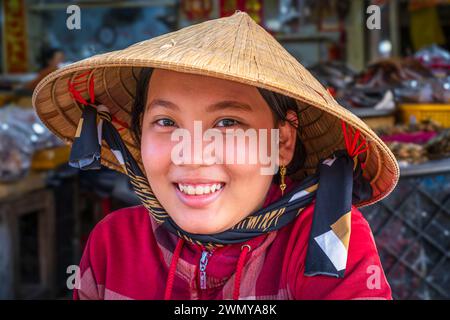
[74,206,164,299]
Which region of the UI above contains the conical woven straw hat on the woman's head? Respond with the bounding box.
[33,11,399,206]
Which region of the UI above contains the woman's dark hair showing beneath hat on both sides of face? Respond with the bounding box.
[131,68,306,176]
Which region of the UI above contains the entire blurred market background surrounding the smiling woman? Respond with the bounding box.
[0,0,450,299]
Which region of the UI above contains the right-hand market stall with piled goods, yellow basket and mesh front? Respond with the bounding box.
[311,3,450,299]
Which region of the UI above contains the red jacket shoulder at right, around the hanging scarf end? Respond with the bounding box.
[285,203,391,299]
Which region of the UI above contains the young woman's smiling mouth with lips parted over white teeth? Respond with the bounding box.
[173,181,225,208]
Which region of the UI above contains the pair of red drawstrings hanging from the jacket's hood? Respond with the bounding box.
[164,238,252,300]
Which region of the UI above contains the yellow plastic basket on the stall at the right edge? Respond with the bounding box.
[400,103,450,128]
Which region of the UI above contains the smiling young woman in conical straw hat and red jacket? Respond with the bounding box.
[33,12,398,299]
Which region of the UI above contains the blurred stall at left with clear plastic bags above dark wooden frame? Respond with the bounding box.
[0,104,138,299]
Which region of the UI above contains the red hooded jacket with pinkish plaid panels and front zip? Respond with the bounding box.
[74,179,392,300]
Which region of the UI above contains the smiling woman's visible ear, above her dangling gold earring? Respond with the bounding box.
[278,110,298,166]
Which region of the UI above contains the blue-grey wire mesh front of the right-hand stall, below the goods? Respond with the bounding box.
[362,158,450,300]
